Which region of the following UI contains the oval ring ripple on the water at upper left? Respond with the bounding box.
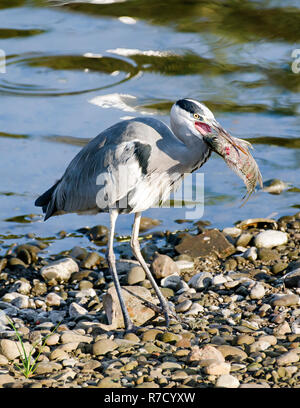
[0,53,138,96]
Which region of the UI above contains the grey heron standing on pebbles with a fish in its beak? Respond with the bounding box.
[35,98,259,331]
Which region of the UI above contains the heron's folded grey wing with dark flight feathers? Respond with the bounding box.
[45,135,150,218]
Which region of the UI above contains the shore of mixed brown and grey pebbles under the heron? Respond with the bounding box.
[0,213,300,389]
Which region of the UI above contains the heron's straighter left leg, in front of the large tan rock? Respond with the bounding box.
[106,210,134,331]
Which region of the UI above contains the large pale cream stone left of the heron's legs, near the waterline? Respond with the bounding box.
[41,258,79,282]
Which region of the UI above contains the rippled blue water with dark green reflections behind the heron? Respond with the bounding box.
[0,0,300,251]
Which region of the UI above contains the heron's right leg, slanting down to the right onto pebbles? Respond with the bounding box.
[130,212,169,327]
